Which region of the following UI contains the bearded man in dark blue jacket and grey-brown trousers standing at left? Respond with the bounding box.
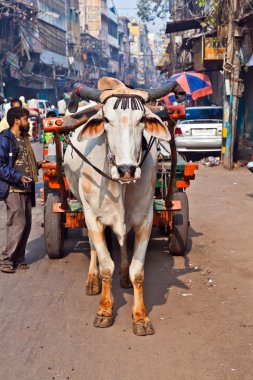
[0,108,43,273]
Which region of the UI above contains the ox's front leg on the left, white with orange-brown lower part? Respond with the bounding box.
[88,221,114,327]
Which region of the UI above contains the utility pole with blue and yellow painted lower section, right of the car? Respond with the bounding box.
[221,0,243,170]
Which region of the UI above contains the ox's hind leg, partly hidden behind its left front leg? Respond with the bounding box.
[86,238,100,296]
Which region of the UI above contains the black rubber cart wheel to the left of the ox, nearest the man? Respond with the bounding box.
[44,193,64,259]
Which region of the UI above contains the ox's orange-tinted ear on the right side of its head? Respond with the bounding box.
[145,107,171,141]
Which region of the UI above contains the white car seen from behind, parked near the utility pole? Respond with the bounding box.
[175,106,223,153]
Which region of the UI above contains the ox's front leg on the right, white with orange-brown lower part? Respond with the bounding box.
[130,224,155,336]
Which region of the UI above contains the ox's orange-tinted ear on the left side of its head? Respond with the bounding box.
[78,110,104,141]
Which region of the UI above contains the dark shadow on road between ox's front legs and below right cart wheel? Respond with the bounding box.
[107,227,202,315]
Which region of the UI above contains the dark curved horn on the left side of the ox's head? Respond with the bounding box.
[68,83,101,113]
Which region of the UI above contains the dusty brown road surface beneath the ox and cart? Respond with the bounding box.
[0,143,253,380]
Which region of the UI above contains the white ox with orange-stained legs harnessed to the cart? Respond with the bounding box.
[64,78,182,335]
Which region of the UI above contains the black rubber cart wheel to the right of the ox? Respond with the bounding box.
[169,191,189,256]
